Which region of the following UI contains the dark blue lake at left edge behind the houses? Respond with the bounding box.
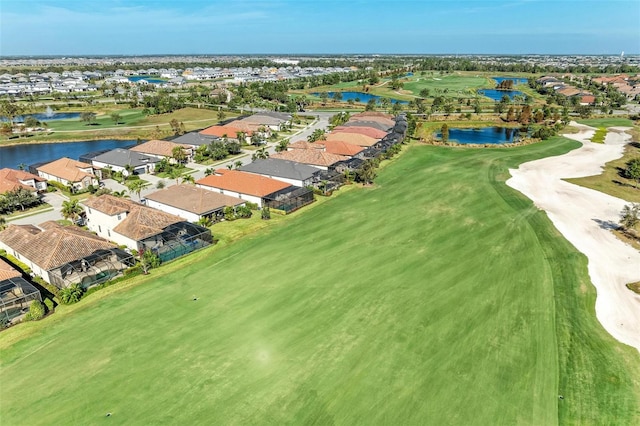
[0,139,136,169]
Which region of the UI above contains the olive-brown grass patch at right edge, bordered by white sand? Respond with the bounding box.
[566,142,640,203]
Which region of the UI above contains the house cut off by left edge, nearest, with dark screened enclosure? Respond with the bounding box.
[0,257,42,325]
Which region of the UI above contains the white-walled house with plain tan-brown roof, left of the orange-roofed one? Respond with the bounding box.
[145,184,245,222]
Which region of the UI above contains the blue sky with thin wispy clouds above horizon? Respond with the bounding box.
[0,0,640,56]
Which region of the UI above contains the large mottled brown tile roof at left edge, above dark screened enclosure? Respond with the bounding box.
[0,222,116,271]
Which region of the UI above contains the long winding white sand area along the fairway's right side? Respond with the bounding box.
[506,122,640,351]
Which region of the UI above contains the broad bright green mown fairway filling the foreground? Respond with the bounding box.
[0,138,640,425]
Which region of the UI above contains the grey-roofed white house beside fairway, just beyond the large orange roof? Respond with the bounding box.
[238,157,321,187]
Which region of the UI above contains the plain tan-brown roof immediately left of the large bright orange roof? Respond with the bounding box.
[147,184,244,215]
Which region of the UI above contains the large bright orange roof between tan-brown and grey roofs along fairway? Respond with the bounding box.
[196,169,291,197]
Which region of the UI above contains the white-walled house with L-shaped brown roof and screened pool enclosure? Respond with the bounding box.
[82,194,213,261]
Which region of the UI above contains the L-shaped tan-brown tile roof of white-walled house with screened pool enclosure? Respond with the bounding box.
[82,194,184,241]
